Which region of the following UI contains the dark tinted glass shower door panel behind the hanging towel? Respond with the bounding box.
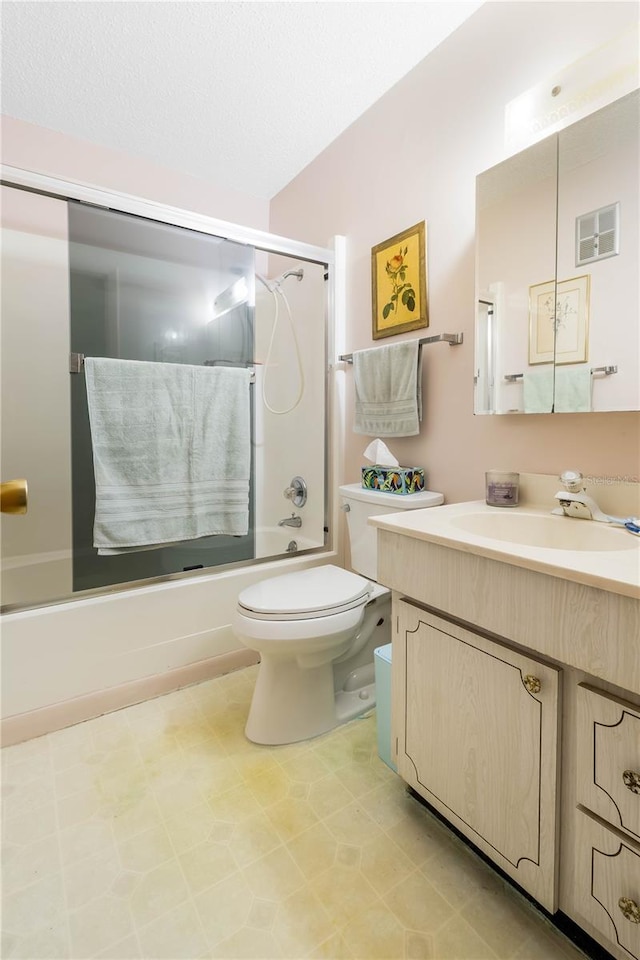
[69,202,255,591]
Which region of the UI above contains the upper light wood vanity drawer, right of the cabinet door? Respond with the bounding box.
[577,683,640,839]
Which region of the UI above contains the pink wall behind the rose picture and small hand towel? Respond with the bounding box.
[271,2,640,501]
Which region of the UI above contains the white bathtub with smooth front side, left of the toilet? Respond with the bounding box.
[1,548,337,745]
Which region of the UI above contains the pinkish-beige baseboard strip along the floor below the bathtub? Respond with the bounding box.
[0,650,259,747]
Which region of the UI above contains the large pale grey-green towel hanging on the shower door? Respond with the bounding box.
[84,358,251,554]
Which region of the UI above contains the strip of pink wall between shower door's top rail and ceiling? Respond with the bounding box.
[2,116,269,230]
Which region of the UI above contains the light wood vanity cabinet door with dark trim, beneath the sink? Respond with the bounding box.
[393,600,559,912]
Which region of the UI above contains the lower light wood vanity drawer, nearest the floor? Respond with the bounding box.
[575,809,640,960]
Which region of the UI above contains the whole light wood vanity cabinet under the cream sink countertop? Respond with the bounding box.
[378,528,640,960]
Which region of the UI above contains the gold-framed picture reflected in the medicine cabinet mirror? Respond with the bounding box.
[529,274,591,366]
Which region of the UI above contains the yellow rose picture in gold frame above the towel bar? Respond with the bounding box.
[371,220,429,340]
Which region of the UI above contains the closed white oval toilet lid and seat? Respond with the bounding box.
[238,564,374,619]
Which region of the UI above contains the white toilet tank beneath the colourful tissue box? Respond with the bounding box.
[339,483,444,580]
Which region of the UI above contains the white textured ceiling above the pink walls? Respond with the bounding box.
[1,0,481,198]
